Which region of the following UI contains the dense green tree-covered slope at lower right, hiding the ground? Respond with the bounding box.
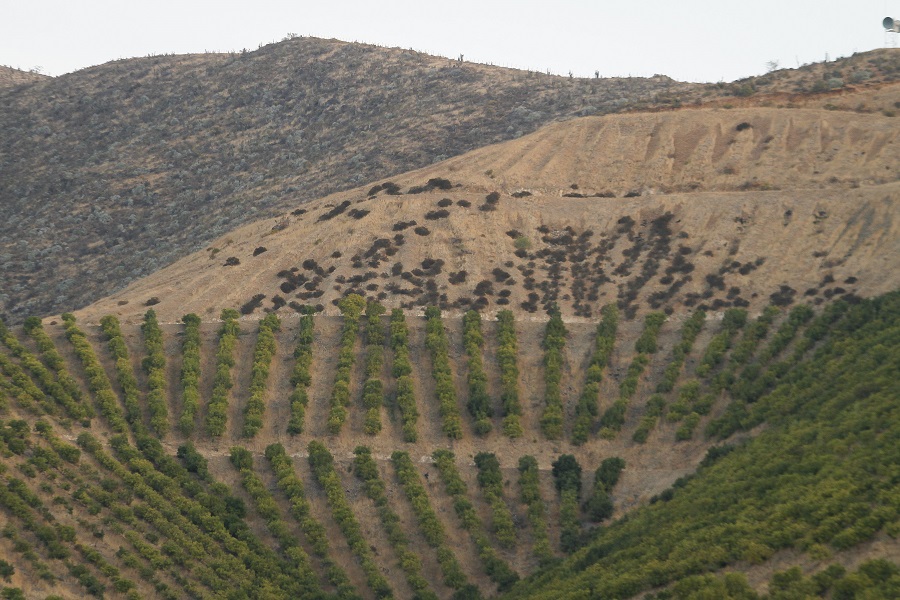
[510,293,900,600]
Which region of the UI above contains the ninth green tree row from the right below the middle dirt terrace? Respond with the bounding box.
[265,444,359,600]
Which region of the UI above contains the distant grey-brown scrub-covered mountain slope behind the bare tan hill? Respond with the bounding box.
[0,38,696,318]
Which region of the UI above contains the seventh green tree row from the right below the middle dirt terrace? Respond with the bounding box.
[353,446,437,600]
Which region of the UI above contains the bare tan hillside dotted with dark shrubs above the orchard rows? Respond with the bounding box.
[78,86,900,322]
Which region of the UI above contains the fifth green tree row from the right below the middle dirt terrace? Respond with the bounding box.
[431,450,519,592]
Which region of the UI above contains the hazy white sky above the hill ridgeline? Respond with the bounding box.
[0,0,900,81]
